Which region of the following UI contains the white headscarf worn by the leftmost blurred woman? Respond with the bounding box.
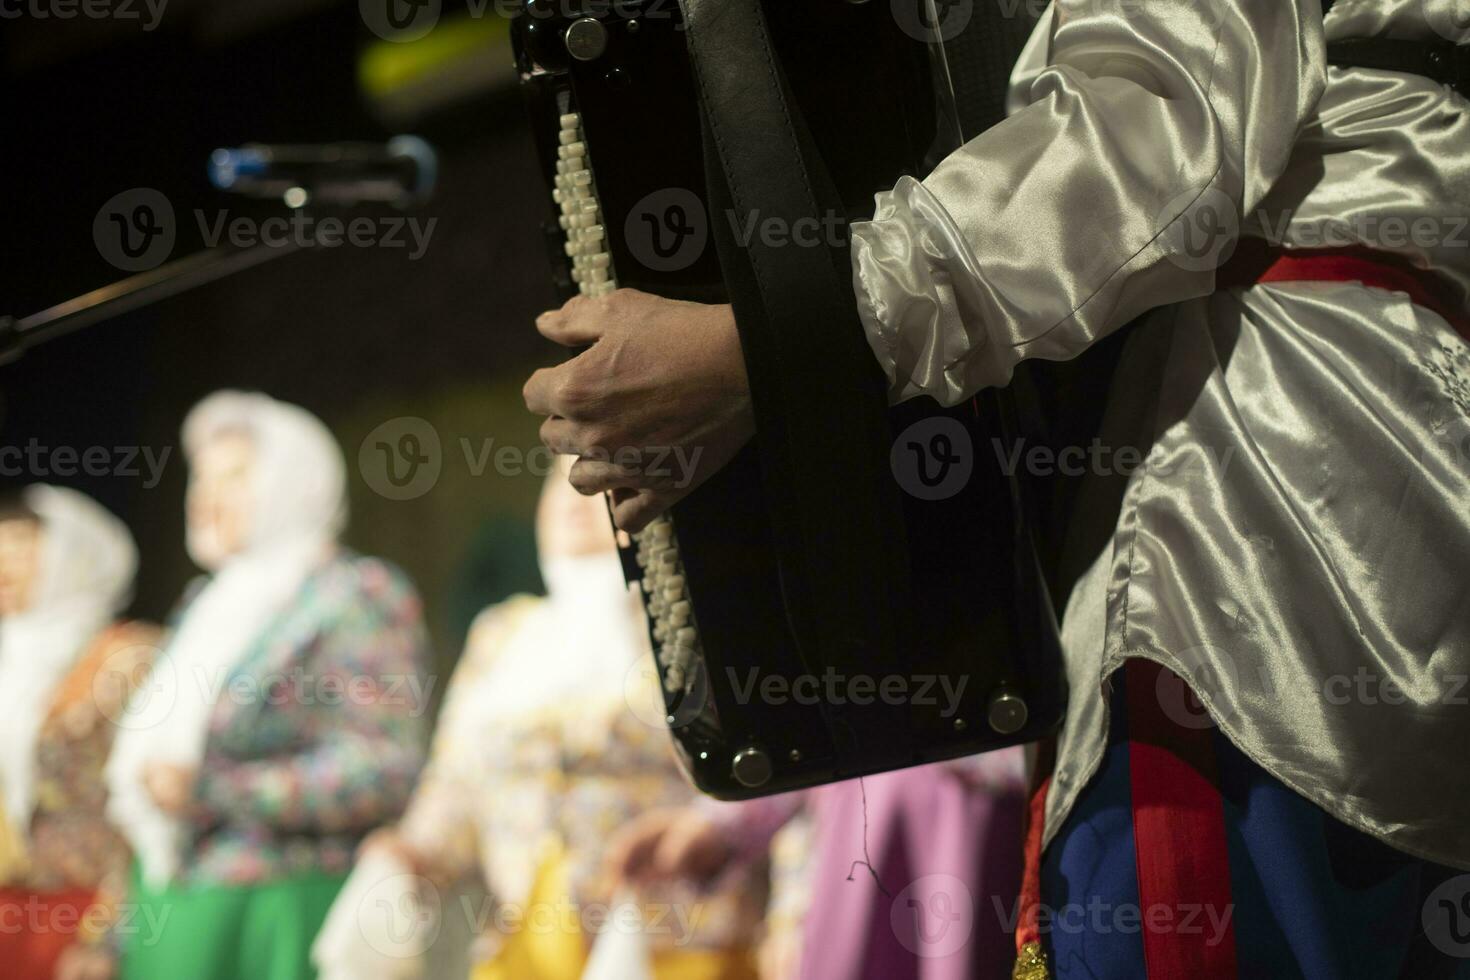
[0,483,138,835]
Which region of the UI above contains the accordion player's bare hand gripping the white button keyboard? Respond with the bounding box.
[525,289,756,530]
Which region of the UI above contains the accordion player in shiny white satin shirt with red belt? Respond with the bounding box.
[526,0,1470,979]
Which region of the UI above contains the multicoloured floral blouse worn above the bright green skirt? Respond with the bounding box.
[181,554,432,884]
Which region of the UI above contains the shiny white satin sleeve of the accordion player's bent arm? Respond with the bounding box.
[853,0,1326,404]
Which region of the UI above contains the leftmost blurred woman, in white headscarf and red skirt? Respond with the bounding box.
[0,485,159,980]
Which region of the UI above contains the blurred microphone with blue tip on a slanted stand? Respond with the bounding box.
[209,137,438,207]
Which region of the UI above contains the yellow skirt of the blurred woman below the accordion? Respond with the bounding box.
[470,855,759,980]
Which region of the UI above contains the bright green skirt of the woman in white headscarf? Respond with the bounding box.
[118,865,347,980]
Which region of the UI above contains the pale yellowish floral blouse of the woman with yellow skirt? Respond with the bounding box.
[400,597,764,958]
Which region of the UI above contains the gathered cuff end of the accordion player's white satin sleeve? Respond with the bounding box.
[851,176,1010,406]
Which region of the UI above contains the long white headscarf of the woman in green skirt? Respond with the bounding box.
[107,391,347,886]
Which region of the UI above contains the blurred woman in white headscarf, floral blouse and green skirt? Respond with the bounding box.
[65,391,428,980]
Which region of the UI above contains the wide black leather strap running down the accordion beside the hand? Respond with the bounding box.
[682,0,913,768]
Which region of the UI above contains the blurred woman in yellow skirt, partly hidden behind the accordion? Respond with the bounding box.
[318,467,764,980]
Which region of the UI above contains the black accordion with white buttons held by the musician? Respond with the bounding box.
[513,0,1064,799]
